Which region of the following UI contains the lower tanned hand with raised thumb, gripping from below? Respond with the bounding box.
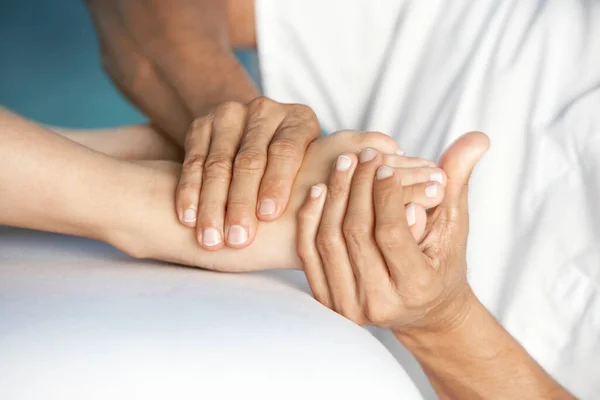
[298,133,489,333]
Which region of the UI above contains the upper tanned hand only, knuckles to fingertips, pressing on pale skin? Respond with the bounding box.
[176,97,321,250]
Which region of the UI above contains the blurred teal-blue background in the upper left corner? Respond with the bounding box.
[0,0,258,128]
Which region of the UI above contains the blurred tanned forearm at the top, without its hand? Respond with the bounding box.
[86,0,259,141]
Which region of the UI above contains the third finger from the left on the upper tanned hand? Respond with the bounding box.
[225,98,284,248]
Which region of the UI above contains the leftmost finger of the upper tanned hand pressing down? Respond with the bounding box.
[175,115,212,227]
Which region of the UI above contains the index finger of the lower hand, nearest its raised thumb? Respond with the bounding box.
[373,166,428,284]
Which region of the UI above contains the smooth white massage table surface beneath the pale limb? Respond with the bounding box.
[0,227,435,400]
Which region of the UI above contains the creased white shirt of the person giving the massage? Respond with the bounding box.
[256,0,600,398]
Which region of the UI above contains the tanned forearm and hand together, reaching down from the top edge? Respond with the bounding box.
[87,0,320,250]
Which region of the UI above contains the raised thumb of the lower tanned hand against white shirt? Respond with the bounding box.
[440,132,490,220]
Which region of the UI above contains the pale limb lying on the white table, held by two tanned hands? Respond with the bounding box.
[0,109,440,271]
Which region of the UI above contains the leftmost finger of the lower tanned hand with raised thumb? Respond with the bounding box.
[297,184,333,308]
